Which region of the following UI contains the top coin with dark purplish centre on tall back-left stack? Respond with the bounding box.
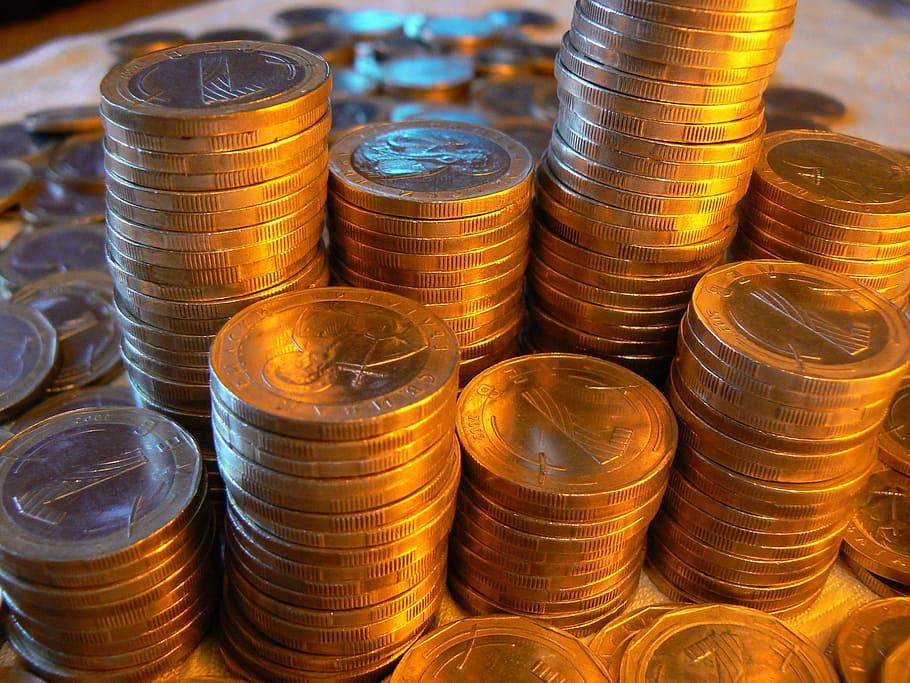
[101,41,331,137]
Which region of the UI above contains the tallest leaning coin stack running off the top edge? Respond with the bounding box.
[526,0,796,381]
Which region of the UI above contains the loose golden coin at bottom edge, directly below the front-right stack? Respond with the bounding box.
[620,604,838,683]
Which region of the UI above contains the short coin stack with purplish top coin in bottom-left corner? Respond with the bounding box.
[0,407,218,681]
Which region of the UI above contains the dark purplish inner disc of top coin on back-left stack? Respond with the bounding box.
[129,48,307,108]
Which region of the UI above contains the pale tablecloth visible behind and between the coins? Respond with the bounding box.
[0,0,910,676]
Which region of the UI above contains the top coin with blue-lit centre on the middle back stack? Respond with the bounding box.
[329,121,534,219]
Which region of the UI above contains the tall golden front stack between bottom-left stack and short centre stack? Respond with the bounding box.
[211,287,461,681]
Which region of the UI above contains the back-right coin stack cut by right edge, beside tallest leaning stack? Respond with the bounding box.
[733,130,910,306]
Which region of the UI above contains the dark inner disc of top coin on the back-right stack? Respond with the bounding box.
[768,140,910,203]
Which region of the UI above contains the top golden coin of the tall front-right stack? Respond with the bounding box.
[688,260,910,396]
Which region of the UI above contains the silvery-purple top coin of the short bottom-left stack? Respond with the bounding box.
[0,407,201,562]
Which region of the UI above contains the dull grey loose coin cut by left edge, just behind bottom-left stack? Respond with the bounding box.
[0,301,58,418]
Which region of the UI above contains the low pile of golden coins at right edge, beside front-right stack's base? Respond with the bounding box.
[842,468,910,597]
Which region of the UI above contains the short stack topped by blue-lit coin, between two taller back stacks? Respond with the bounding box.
[328,121,534,384]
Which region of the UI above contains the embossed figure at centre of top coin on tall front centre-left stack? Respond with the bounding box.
[262,302,429,401]
